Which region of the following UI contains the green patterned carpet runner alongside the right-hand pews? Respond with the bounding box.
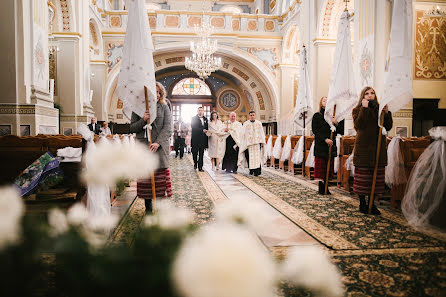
[236,172,446,249]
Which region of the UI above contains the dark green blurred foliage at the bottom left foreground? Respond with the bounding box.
[0,215,196,297]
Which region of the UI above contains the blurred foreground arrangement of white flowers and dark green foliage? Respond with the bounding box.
[0,136,344,297]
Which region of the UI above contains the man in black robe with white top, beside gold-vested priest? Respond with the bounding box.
[221,112,243,173]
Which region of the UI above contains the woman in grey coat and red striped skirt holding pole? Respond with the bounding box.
[130,82,172,213]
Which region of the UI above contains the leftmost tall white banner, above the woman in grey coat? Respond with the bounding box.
[116,0,156,123]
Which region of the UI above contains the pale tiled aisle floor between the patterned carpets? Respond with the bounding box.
[200,158,319,247]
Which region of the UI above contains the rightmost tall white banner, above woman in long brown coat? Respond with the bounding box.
[378,0,413,124]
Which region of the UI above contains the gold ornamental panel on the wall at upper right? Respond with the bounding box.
[414,10,446,80]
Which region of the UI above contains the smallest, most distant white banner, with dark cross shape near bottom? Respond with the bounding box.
[294,46,313,133]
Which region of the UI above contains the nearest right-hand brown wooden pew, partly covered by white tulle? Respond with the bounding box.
[390,136,431,208]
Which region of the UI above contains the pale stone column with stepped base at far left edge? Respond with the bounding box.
[0,0,58,135]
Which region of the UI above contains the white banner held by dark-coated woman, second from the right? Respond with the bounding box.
[324,11,359,127]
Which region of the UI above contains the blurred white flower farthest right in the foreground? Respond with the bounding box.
[281,246,344,297]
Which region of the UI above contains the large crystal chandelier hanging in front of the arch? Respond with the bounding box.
[185,18,222,79]
